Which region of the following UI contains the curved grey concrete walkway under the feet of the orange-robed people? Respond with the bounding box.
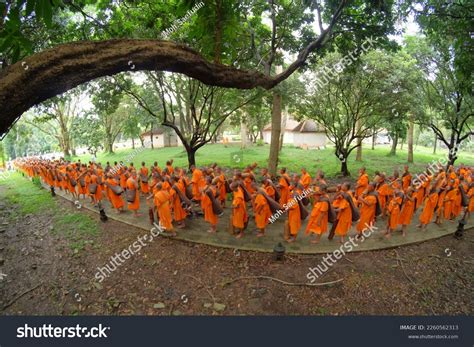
[45,187,474,254]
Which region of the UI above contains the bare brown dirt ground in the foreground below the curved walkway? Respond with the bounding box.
[0,186,474,315]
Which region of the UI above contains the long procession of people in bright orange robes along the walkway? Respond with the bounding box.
[14,158,474,243]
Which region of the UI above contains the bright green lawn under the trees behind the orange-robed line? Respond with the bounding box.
[73,144,474,177]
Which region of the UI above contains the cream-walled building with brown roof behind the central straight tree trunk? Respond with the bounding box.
[263,118,327,148]
